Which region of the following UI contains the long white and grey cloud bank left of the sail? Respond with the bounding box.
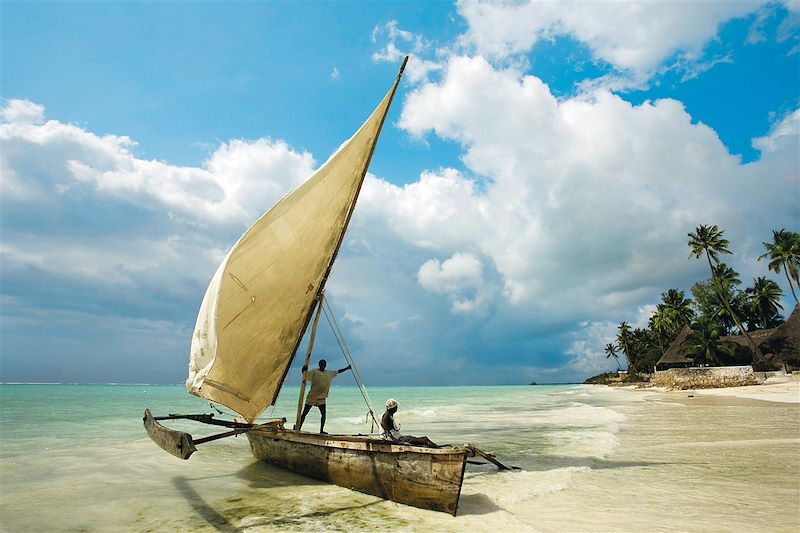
[0,100,314,292]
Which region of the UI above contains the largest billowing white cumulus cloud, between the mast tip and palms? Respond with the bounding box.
[376,57,798,320]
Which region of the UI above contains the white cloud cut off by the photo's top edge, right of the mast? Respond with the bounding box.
[458,0,767,86]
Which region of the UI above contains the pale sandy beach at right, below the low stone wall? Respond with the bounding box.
[524,383,800,532]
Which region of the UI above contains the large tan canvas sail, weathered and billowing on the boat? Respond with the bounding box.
[186,69,402,421]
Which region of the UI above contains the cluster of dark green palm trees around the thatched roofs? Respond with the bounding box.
[604,225,800,374]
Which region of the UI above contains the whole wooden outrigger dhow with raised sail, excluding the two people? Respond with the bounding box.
[144,58,507,515]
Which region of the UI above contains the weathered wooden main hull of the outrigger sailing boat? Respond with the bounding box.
[247,426,468,516]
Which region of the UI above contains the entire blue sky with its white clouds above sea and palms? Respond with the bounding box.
[0,1,800,385]
